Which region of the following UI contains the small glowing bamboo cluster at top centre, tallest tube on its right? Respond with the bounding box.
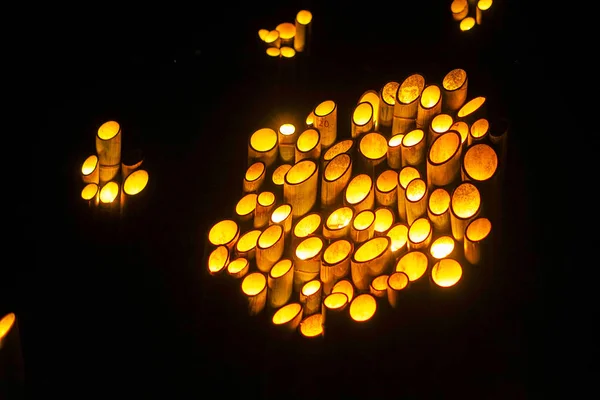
[258,10,313,58]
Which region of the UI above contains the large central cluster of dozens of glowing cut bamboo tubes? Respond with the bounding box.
[205,68,508,337]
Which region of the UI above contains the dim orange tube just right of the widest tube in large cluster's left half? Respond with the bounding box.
[321,153,352,209]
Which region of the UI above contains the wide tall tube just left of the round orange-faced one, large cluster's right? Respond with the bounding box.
[427,131,462,187]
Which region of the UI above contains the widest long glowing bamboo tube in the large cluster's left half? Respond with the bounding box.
[283,158,319,218]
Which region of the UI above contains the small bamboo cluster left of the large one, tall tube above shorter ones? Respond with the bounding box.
[80,121,149,216]
